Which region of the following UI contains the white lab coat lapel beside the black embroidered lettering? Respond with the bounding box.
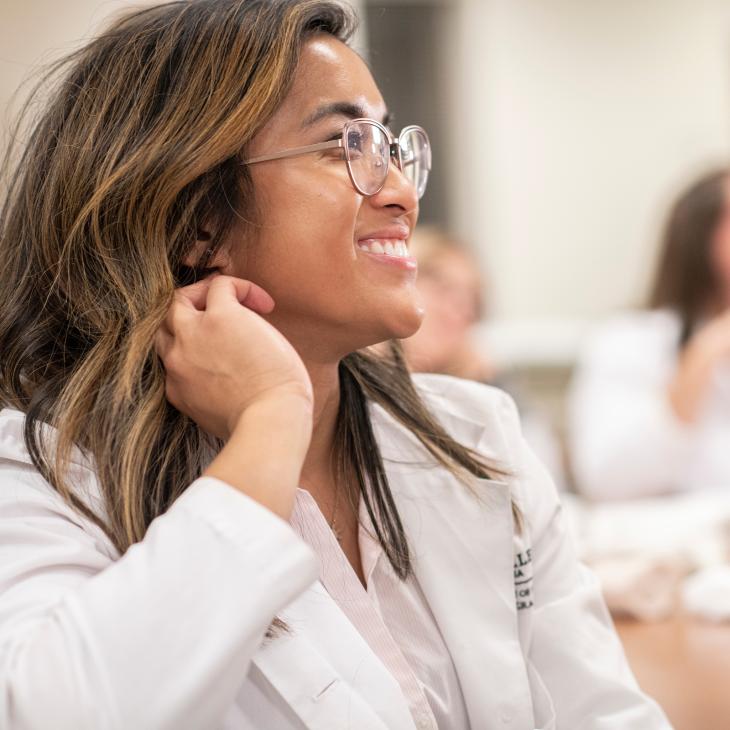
[381,412,534,729]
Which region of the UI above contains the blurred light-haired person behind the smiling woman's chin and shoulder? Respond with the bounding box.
[402,226,565,489]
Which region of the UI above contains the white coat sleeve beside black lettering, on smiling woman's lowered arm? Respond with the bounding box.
[494,396,671,730]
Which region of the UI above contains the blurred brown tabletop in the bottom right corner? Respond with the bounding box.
[615,616,730,730]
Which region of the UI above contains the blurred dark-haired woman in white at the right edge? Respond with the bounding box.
[570,169,730,499]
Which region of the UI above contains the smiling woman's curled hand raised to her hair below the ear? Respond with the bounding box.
[156,275,313,440]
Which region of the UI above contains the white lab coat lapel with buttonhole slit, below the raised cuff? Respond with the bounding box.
[253,582,414,730]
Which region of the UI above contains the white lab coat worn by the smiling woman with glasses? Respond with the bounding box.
[0,376,669,730]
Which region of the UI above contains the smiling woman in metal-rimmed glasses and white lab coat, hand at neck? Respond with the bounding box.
[0,0,668,730]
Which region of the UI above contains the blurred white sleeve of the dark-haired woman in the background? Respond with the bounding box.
[568,319,695,499]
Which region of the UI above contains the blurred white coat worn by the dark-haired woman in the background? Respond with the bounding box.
[569,310,730,499]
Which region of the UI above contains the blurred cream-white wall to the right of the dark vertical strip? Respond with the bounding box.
[448,0,730,362]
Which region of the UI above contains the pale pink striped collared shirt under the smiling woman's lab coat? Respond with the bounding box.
[291,489,469,730]
